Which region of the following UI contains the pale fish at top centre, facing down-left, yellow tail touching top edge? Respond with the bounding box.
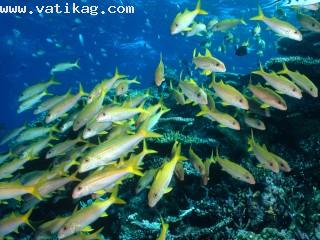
[171,0,208,35]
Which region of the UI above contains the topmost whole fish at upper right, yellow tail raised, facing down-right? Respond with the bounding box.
[250,6,303,41]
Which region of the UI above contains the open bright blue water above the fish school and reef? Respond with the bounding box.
[0,0,288,129]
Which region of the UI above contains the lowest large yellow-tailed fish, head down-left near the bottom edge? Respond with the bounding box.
[58,187,125,239]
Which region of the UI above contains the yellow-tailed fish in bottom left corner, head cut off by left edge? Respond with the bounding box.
[0,209,34,237]
